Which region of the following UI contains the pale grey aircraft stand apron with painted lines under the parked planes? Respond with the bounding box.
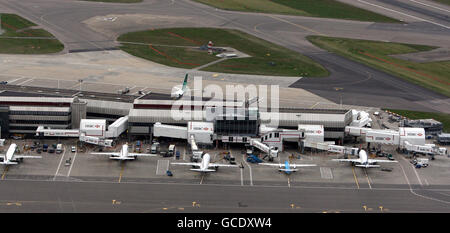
[1,139,450,189]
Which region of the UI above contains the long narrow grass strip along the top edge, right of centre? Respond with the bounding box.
[196,0,400,23]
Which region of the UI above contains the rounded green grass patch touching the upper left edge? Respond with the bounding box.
[0,14,64,54]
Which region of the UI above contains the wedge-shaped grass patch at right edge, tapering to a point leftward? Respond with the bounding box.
[307,36,450,96]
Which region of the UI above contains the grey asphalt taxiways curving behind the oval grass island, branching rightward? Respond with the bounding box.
[0,0,450,112]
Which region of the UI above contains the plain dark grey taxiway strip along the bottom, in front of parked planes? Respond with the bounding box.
[0,180,449,213]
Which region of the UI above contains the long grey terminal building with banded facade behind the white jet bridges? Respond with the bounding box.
[0,90,353,142]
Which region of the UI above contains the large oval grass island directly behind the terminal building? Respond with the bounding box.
[117,28,329,77]
